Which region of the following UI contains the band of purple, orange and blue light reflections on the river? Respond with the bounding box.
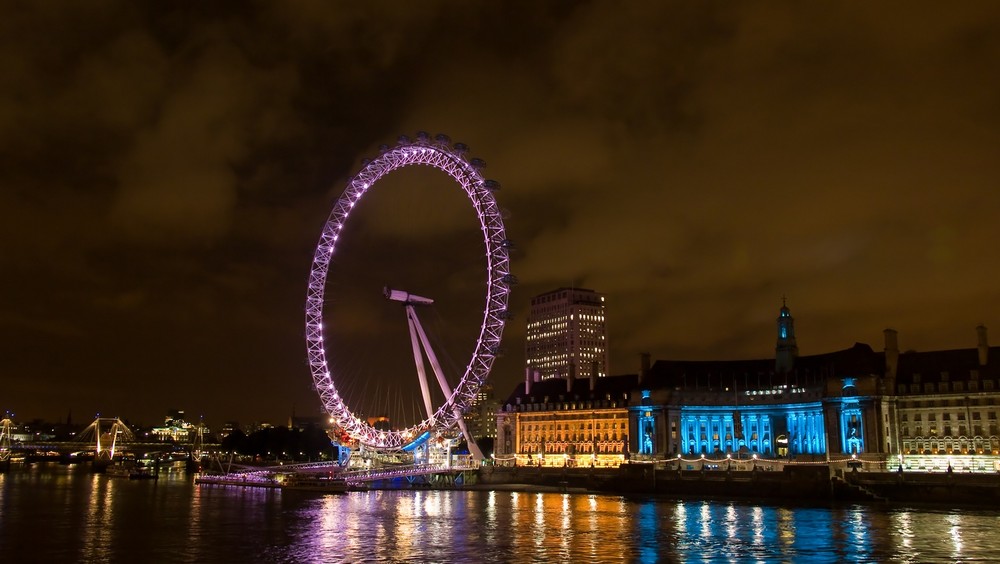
[191,491,997,563]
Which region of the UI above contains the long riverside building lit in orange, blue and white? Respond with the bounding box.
[496,304,1000,471]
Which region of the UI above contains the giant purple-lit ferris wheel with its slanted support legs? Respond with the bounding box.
[305,132,516,450]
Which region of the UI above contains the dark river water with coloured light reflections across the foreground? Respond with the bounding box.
[0,465,1000,564]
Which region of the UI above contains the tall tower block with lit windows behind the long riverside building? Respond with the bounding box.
[525,288,609,380]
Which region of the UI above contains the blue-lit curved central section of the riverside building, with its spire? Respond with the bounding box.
[630,305,887,459]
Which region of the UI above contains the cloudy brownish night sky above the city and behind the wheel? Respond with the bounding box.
[0,0,1000,426]
